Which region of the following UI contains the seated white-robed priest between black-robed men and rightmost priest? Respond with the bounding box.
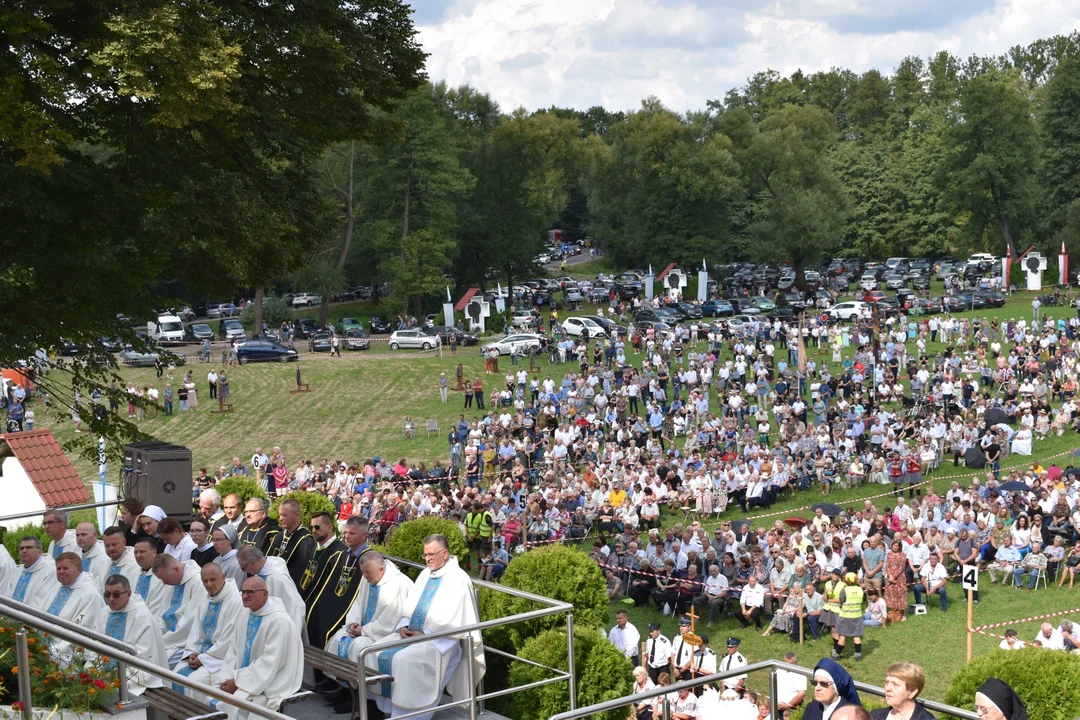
[326,551,413,663]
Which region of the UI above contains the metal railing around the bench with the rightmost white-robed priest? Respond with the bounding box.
[357,556,578,720]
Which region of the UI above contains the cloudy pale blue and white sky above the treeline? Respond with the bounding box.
[411,0,1080,111]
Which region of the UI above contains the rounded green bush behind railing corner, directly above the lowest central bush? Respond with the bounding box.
[481,545,608,650]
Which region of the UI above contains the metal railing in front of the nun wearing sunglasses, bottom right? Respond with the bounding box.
[549,660,980,720]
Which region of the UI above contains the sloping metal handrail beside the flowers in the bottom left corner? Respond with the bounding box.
[0,600,288,720]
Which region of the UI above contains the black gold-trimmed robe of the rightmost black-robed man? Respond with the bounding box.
[301,540,367,648]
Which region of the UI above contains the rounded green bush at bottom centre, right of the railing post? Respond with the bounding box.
[510,627,634,720]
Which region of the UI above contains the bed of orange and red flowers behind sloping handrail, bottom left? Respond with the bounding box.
[0,620,120,712]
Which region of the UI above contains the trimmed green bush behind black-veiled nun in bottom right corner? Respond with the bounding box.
[945,647,1080,720]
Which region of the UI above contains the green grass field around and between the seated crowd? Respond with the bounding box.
[29,280,1080,699]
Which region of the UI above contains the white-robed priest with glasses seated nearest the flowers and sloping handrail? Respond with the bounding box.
[94,575,168,695]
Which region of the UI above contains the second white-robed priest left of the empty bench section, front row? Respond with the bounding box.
[173,562,245,702]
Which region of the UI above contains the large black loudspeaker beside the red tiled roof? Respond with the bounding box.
[124,443,193,524]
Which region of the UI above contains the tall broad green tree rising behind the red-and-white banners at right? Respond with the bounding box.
[937,72,1038,257]
